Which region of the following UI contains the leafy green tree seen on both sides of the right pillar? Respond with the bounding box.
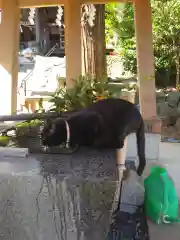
[112,0,180,85]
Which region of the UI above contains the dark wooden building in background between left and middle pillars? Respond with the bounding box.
[20,7,64,57]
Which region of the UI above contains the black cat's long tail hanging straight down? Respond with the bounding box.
[136,119,146,176]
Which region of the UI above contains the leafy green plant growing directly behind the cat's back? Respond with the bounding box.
[50,76,116,112]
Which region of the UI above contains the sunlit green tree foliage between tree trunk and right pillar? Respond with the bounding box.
[106,3,136,73]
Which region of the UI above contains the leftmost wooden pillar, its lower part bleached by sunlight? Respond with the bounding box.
[0,0,20,114]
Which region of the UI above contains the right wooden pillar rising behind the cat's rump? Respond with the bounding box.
[134,0,161,132]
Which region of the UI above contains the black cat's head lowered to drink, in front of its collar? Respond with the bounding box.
[41,119,67,147]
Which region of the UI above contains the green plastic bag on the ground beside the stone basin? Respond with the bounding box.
[144,166,180,224]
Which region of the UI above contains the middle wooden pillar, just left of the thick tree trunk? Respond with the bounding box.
[64,0,82,88]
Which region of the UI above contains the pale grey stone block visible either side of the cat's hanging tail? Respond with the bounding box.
[127,133,161,160]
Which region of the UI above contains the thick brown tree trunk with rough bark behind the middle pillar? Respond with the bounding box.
[82,4,107,78]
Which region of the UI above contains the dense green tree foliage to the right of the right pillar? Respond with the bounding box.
[152,0,180,86]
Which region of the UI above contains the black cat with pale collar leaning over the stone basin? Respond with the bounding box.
[42,99,146,175]
